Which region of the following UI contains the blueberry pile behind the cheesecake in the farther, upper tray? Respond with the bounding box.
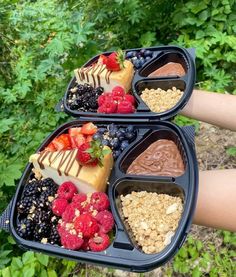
[125,49,153,69]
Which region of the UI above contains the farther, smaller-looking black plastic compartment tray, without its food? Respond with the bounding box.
[60,46,196,120]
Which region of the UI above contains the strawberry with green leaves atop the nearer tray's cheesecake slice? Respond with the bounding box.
[77,140,110,166]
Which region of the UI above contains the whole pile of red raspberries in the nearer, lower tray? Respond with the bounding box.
[52,182,114,252]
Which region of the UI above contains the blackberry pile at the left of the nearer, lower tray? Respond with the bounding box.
[16,178,60,244]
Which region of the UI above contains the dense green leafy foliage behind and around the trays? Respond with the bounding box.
[0,0,236,277]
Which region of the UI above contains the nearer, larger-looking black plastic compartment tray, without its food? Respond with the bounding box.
[10,119,198,272]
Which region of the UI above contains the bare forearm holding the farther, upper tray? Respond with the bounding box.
[181,90,236,131]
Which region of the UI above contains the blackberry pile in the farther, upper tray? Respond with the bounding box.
[67,84,104,112]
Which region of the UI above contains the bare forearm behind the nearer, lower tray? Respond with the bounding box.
[194,169,236,232]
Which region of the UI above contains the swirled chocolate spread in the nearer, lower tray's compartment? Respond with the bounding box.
[127,139,184,177]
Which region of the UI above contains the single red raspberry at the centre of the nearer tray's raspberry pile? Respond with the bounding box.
[74,214,99,238]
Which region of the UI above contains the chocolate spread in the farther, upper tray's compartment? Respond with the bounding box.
[148,62,186,77]
